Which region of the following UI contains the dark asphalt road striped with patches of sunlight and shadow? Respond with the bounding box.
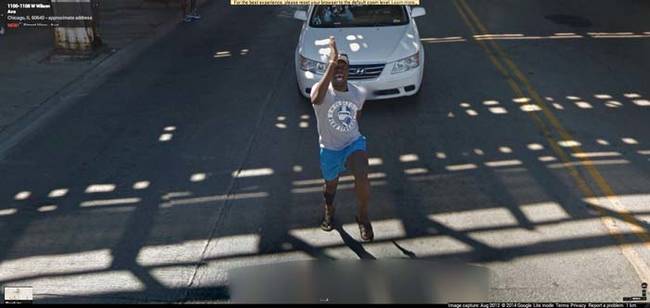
[0,0,650,302]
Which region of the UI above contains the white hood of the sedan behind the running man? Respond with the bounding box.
[298,25,421,64]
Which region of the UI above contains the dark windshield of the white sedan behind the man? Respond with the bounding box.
[310,5,408,28]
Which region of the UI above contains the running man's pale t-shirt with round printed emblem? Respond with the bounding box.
[312,83,366,151]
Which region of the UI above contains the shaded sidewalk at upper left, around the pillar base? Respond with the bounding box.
[0,0,202,142]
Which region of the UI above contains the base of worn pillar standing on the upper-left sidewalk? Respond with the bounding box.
[51,0,102,56]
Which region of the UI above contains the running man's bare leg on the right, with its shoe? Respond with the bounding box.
[348,151,374,240]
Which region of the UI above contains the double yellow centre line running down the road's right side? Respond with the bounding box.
[454,0,650,281]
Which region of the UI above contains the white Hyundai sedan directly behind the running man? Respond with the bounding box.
[294,5,426,99]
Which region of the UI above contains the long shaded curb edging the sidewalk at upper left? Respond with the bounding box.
[0,1,208,160]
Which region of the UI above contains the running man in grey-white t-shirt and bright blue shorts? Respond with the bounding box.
[310,37,374,241]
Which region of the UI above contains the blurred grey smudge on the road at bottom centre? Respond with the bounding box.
[229,259,489,304]
